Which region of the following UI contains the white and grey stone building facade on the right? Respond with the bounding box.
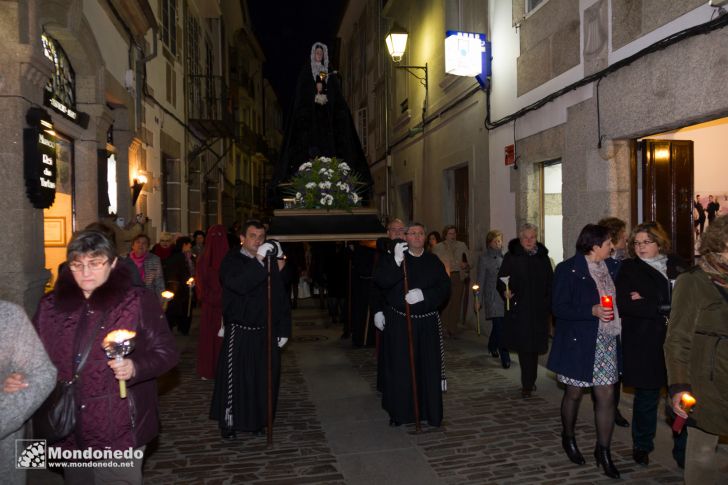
[489,0,728,261]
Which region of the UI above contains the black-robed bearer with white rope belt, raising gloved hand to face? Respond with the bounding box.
[210,221,291,439]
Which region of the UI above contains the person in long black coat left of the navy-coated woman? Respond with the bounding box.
[498,223,554,397]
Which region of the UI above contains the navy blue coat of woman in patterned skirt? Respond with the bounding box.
[546,253,620,382]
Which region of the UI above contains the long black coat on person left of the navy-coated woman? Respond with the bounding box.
[496,239,554,354]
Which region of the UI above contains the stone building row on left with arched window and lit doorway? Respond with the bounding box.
[0,0,278,314]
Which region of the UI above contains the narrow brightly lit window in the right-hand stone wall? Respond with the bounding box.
[539,160,564,264]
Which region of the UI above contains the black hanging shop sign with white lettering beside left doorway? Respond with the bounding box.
[23,108,58,209]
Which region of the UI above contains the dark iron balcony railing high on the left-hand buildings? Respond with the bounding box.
[187,74,235,138]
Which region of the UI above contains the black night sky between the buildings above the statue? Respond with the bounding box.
[248,0,347,117]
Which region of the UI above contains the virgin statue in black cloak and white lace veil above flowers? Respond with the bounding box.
[270,42,372,207]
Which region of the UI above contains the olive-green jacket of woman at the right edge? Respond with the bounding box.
[664,267,728,435]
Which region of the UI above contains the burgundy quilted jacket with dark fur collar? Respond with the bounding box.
[33,264,179,450]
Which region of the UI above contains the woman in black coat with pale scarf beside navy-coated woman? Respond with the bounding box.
[616,222,687,466]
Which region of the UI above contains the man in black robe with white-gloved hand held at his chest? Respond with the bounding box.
[374,223,450,426]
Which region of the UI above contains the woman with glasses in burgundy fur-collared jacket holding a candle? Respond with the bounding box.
[33,231,179,483]
